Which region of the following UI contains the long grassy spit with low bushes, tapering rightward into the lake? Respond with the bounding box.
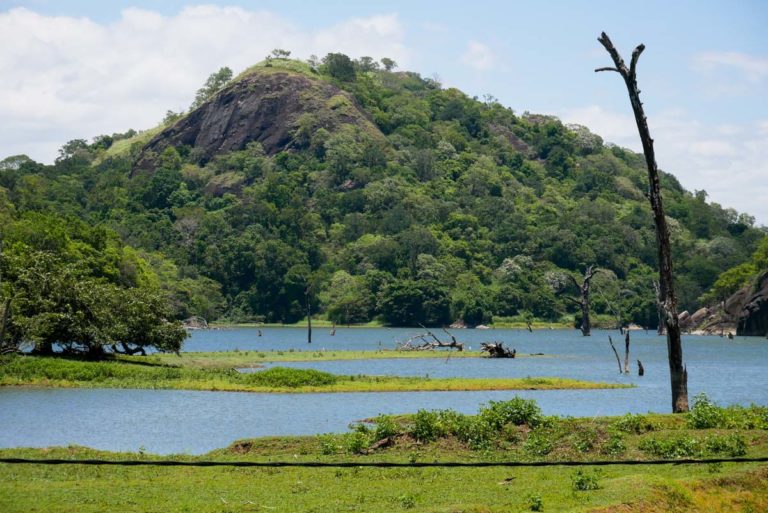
[0,356,623,393]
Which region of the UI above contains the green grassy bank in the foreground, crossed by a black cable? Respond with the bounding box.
[0,400,768,513]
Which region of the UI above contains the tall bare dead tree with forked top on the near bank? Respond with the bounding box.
[595,32,688,413]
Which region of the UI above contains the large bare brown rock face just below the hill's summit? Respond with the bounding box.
[134,68,383,174]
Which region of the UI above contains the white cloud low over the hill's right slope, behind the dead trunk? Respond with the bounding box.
[561,105,768,225]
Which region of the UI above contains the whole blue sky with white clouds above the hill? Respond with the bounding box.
[0,0,768,224]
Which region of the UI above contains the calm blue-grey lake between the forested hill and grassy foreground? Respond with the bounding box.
[0,328,768,454]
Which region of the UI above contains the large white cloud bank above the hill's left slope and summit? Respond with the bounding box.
[0,5,410,162]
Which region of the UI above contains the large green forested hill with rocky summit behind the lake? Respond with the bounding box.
[0,53,765,326]
